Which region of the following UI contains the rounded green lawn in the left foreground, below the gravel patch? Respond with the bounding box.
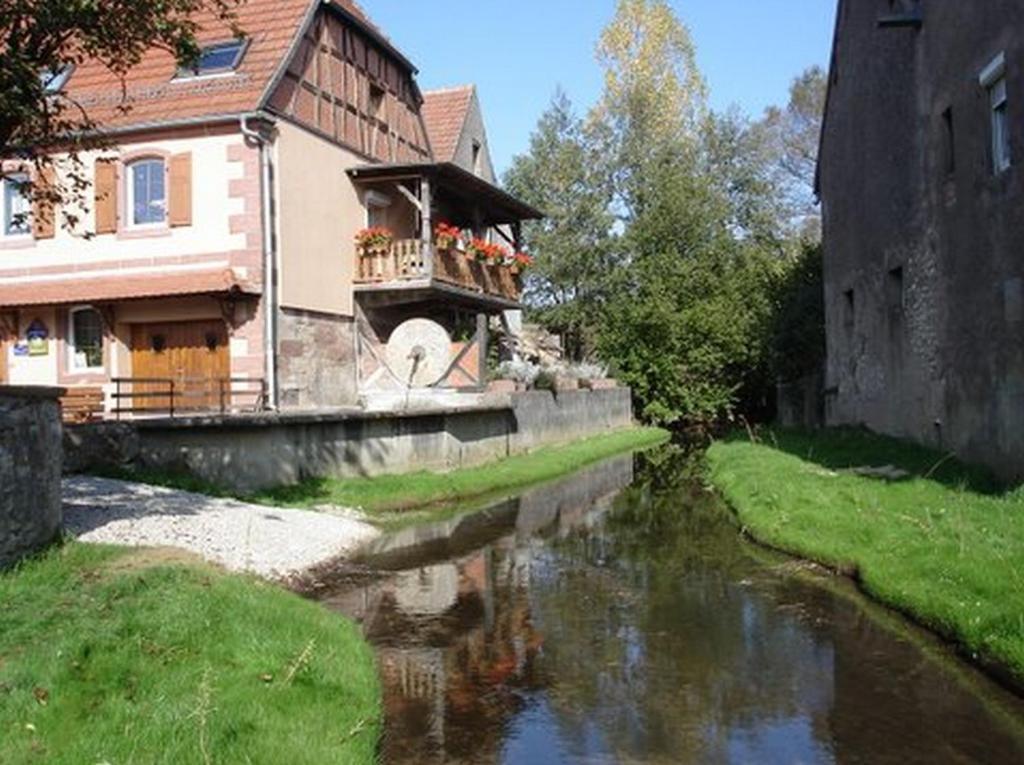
[0,543,380,765]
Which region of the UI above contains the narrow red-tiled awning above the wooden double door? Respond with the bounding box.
[0,268,259,307]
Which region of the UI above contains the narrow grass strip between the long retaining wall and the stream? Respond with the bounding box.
[248,428,670,525]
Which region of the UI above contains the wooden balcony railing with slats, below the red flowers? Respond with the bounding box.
[355,240,522,302]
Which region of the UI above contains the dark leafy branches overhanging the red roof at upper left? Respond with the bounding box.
[0,0,241,222]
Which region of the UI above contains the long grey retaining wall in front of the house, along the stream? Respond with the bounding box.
[65,388,633,492]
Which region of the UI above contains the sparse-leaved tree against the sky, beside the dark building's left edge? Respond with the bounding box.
[756,67,828,239]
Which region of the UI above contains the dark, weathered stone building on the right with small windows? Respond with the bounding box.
[818,0,1024,478]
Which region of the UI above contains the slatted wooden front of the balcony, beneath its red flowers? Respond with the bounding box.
[355,239,522,308]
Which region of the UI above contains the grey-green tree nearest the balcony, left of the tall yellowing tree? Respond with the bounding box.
[505,91,614,358]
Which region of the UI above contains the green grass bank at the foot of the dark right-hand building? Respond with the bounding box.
[708,430,1024,683]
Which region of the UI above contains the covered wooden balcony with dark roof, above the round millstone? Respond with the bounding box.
[349,163,542,312]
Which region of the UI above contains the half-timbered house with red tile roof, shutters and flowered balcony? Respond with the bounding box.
[0,0,540,414]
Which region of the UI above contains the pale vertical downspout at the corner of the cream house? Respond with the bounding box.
[239,113,278,412]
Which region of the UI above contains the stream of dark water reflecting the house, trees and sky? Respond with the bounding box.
[313,452,1024,765]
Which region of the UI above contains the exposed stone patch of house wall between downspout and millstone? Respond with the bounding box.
[278,308,358,410]
